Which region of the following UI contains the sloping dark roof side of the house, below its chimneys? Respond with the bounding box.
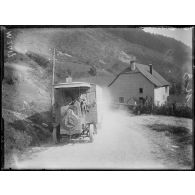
[124,63,170,87]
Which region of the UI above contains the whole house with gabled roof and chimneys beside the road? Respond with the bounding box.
[109,62,170,105]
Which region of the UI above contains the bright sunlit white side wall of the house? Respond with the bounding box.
[154,86,169,106]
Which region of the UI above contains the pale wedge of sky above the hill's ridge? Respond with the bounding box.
[143,27,192,48]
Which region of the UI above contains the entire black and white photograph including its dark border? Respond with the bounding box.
[1,25,194,170]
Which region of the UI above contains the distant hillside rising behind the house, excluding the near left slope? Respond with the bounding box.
[5,28,192,83]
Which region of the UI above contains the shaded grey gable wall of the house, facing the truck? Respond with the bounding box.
[110,72,154,103]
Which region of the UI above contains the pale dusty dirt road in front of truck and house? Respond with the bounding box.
[16,111,192,169]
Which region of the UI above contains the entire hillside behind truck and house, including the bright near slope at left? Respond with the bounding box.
[2,28,192,163]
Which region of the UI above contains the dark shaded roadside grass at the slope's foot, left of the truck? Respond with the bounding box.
[4,111,51,168]
